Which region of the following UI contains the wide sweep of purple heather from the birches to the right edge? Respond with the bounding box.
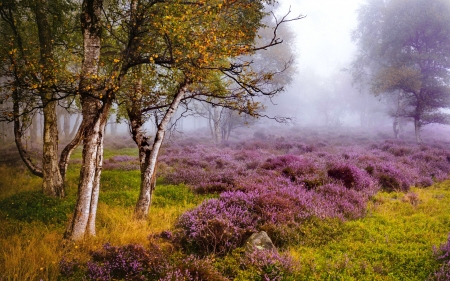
[160,128,450,254]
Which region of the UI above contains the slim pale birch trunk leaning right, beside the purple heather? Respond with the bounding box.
[133,82,187,219]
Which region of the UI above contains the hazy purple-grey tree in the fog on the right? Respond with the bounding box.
[353,0,450,142]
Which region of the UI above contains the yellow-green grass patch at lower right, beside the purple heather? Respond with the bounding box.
[290,184,450,280]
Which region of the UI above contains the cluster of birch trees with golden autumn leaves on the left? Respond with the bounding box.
[0,0,298,240]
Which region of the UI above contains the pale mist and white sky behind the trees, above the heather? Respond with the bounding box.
[4,0,449,141]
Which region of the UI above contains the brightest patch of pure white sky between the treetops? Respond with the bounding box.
[279,0,363,75]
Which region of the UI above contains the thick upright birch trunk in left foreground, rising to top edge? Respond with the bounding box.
[64,0,106,240]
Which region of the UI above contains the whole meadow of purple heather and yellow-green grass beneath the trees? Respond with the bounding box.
[0,126,450,281]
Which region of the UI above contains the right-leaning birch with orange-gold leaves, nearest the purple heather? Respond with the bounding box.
[118,1,302,219]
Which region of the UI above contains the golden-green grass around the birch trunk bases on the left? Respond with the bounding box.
[0,160,211,281]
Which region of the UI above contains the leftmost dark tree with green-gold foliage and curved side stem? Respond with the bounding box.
[0,0,80,197]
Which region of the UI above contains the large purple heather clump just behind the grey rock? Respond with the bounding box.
[177,185,368,254]
